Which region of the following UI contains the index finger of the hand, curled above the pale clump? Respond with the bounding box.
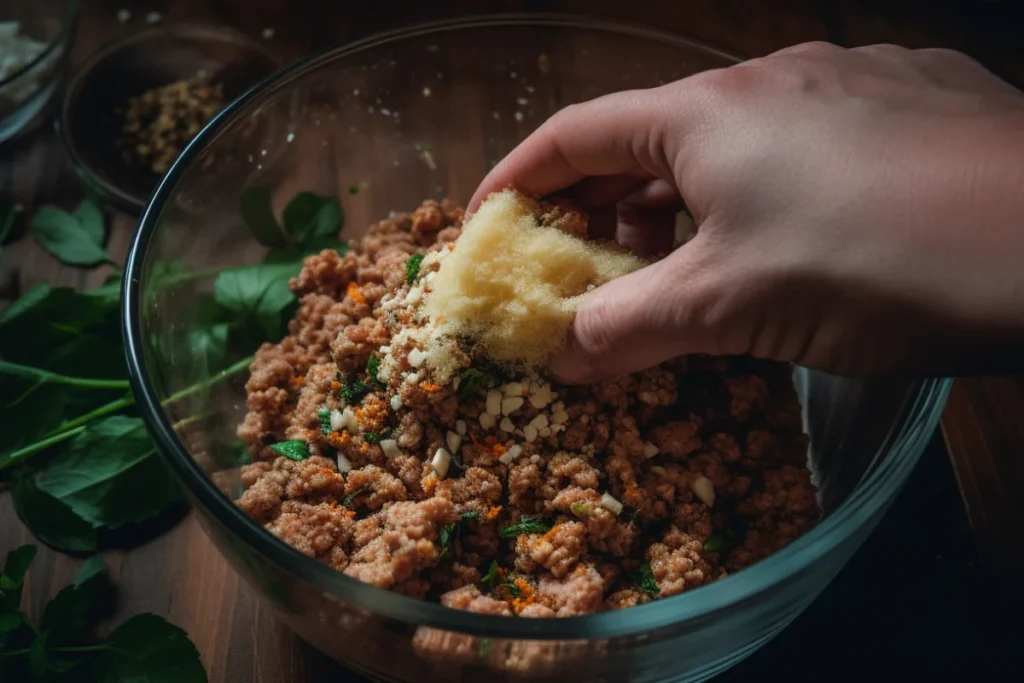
[467,88,673,212]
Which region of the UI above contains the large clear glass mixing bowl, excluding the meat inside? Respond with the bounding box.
[124,15,948,683]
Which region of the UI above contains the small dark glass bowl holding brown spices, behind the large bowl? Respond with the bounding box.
[56,26,281,213]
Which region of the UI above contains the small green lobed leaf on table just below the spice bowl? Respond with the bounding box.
[32,200,114,266]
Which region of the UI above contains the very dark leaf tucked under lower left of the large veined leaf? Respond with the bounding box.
[11,472,96,552]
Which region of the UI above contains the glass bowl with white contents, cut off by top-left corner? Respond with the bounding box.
[0,0,78,142]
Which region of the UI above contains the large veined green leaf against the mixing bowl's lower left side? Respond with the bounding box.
[38,416,181,528]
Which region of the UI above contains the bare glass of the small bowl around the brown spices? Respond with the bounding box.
[56,25,282,214]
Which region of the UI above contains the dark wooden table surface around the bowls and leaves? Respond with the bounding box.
[0,0,1024,683]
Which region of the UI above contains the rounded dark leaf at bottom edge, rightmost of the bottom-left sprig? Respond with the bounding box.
[94,614,207,683]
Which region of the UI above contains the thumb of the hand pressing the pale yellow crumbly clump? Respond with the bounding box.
[549,243,698,384]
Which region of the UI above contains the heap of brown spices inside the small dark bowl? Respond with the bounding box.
[118,76,224,173]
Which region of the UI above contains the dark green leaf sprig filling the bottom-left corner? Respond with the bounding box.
[0,546,207,683]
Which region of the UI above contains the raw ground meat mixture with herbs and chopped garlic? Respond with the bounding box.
[237,201,820,617]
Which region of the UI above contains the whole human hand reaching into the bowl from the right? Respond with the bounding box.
[469,43,1024,383]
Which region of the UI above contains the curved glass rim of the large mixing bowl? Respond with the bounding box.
[122,12,951,640]
